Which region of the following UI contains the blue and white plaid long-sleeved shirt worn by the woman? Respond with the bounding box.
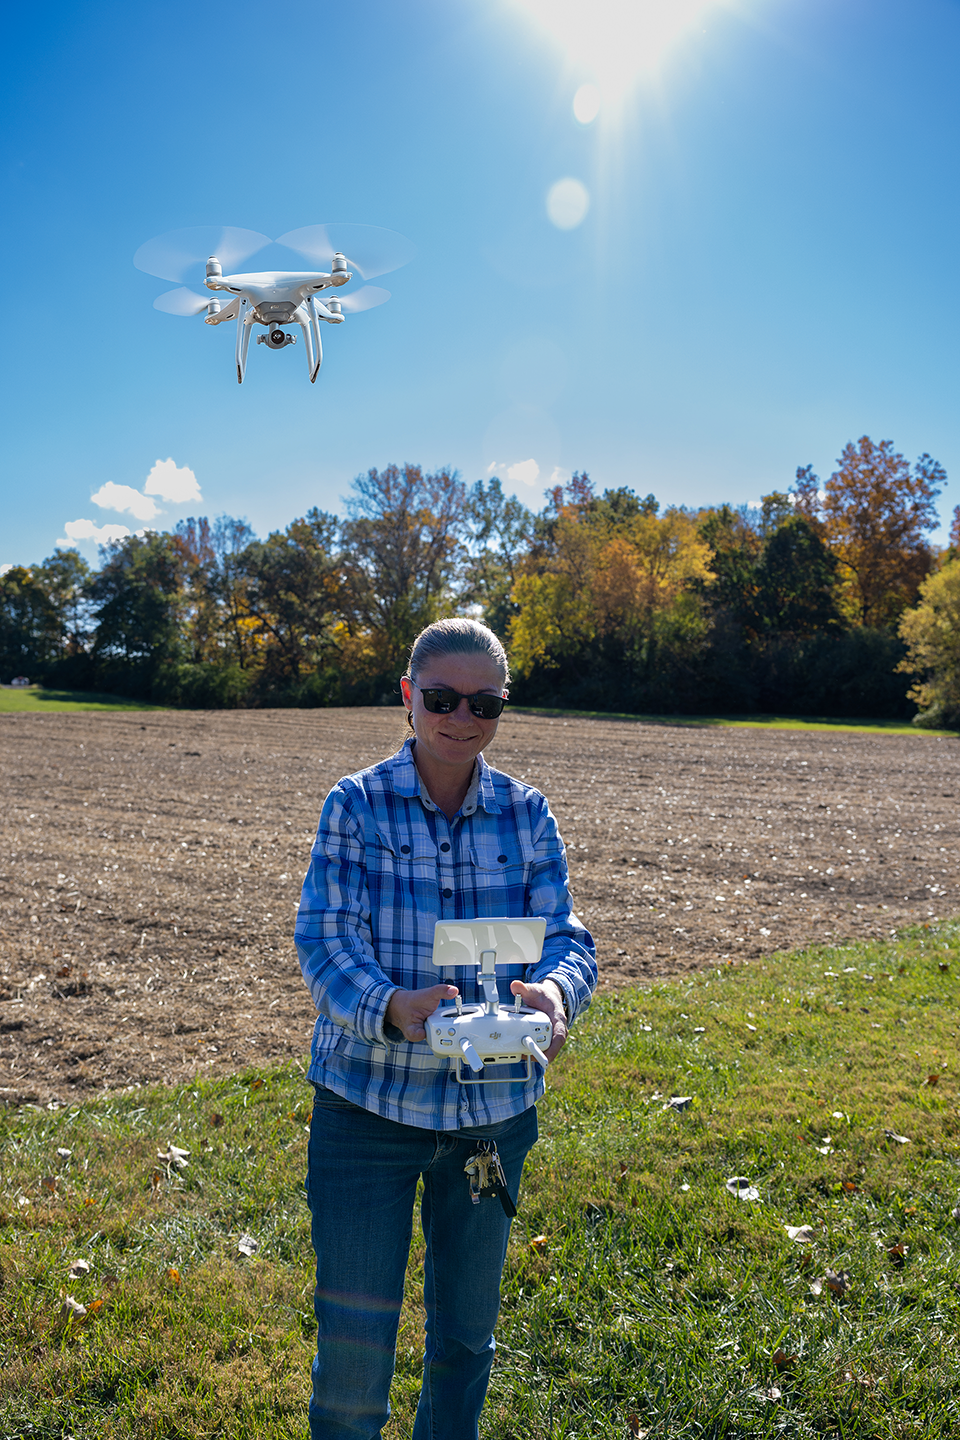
[295,740,597,1130]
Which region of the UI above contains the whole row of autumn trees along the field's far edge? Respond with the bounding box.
[0,436,960,724]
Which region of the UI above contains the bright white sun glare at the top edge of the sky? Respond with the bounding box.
[514,0,720,99]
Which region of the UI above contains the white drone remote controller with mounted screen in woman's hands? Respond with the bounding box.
[426,919,553,1084]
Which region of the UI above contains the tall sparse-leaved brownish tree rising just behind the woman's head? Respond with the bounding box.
[341,465,466,675]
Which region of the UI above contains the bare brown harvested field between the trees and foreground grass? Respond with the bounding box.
[0,708,960,1104]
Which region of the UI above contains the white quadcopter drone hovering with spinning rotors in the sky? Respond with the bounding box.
[134,225,413,384]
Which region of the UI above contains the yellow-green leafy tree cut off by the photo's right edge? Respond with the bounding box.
[897,557,960,726]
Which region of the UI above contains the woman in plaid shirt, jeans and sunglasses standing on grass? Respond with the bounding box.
[296,619,596,1440]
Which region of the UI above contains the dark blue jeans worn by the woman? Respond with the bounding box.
[307,1086,537,1440]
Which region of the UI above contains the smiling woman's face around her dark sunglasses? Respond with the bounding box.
[400,655,507,770]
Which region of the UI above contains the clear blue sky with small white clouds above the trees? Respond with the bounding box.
[0,0,960,566]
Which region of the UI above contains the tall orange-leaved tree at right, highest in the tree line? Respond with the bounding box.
[794,435,947,625]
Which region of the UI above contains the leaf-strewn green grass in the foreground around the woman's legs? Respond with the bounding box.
[0,923,960,1440]
